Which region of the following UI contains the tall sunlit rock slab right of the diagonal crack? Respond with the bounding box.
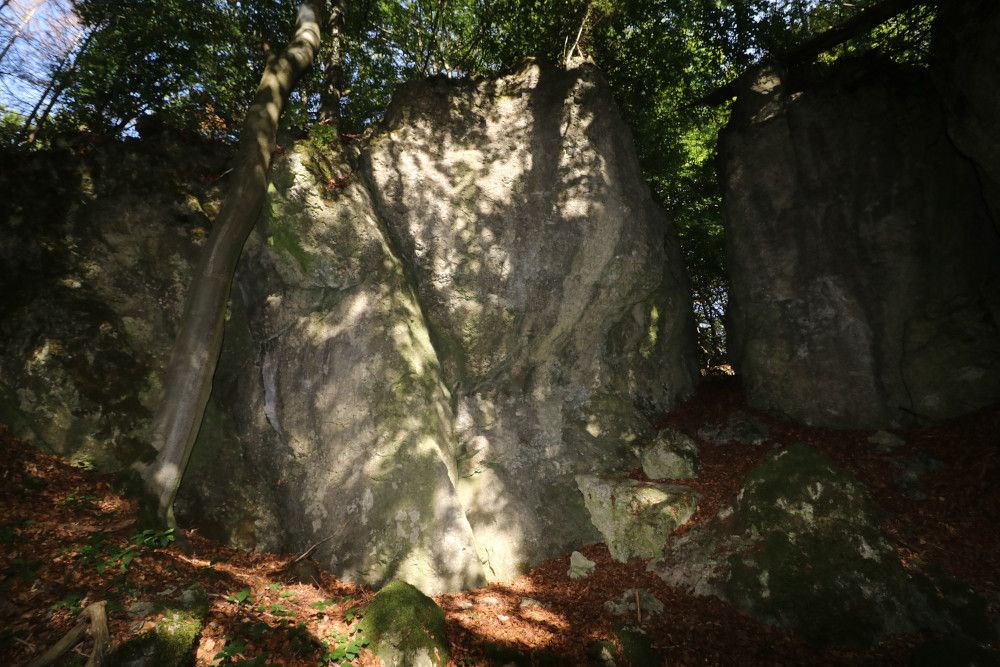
[366,65,694,577]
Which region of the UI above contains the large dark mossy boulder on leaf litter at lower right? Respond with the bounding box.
[650,445,989,644]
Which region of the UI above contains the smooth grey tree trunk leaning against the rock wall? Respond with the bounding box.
[140,2,320,525]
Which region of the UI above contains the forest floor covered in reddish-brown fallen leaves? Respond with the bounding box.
[0,379,1000,666]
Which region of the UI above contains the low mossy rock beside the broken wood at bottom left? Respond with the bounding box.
[107,587,208,667]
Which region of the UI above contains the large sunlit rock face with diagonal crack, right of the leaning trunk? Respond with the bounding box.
[178,66,694,592]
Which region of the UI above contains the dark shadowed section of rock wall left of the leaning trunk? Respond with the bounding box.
[0,137,227,471]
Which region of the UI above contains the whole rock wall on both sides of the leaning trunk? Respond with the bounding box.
[0,65,695,593]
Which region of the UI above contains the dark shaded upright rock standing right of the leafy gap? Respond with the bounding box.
[720,62,1000,428]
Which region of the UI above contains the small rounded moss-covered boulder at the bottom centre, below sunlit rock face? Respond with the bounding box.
[359,580,448,667]
